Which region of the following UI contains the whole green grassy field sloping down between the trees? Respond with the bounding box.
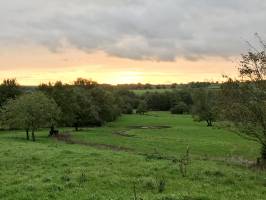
[0,112,266,200]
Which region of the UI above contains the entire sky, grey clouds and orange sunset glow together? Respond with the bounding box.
[0,0,266,85]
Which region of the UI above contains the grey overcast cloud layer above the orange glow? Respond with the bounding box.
[0,0,266,84]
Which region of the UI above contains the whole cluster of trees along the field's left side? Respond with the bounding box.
[0,78,137,141]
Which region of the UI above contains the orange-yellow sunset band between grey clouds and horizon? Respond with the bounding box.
[0,47,237,85]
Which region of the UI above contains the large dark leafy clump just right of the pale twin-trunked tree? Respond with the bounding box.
[39,78,122,130]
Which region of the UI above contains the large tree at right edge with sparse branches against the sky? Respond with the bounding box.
[222,35,266,164]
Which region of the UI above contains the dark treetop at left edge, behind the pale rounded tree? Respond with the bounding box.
[0,79,21,106]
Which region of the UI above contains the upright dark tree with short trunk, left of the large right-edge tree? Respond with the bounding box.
[192,89,217,126]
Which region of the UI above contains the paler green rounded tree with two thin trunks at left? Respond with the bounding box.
[1,92,60,141]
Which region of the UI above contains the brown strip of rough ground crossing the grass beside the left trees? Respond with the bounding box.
[55,133,133,152]
